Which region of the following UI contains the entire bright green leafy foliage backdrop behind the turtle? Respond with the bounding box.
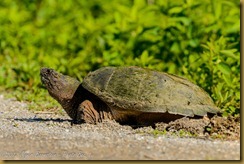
[0,0,240,114]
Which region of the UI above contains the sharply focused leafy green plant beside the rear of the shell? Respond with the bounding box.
[185,37,240,115]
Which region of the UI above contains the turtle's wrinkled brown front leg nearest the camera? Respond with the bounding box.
[78,100,101,124]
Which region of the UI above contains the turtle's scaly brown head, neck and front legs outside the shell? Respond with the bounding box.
[40,68,113,124]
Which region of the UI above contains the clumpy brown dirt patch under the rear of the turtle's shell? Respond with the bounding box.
[156,116,240,140]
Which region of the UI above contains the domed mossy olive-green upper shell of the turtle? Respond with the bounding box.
[82,67,219,117]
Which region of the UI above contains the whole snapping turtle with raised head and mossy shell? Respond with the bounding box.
[40,66,220,125]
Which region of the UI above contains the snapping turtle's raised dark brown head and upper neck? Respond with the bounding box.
[40,68,80,105]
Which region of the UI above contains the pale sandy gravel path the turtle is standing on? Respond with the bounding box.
[0,95,240,160]
